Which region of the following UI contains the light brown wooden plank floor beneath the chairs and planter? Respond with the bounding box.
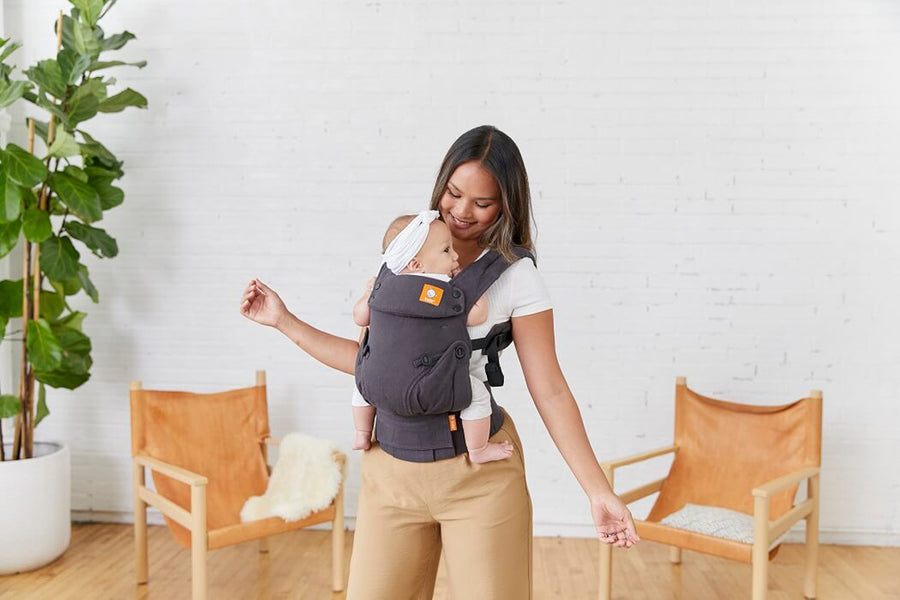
[0,524,900,600]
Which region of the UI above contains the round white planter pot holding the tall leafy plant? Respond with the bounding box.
[0,442,72,575]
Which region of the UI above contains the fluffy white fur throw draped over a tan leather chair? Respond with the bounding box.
[241,433,341,521]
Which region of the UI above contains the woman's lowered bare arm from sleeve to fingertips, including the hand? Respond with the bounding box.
[512,310,640,547]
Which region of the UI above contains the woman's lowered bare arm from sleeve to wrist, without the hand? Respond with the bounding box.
[512,310,612,498]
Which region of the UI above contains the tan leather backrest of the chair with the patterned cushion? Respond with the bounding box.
[647,378,822,521]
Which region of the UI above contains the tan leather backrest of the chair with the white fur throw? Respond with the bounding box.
[131,372,269,547]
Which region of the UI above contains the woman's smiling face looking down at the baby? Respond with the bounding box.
[438,161,502,241]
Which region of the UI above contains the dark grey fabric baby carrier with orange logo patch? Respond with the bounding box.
[356,246,537,462]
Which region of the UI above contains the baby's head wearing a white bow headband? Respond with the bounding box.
[382,211,459,275]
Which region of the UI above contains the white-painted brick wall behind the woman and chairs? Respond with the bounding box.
[4,0,900,544]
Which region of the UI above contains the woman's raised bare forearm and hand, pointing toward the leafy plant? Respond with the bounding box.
[241,279,362,375]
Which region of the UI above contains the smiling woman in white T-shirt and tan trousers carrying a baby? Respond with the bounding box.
[240,126,639,600]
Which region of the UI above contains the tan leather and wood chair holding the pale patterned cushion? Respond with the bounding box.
[600,377,822,600]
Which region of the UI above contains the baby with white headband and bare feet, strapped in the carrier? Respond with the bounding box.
[351,210,512,463]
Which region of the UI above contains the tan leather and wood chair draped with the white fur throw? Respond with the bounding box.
[131,371,346,600]
